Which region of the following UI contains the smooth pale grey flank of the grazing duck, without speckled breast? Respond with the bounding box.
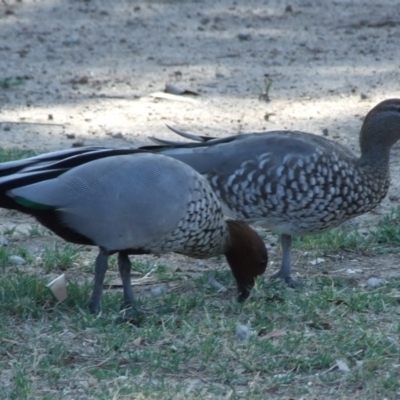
[10,154,189,250]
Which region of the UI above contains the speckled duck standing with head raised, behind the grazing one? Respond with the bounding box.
[143,99,400,285]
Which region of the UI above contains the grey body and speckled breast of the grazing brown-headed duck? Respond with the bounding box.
[10,154,226,255]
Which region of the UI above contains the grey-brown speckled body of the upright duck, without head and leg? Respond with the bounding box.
[152,131,389,234]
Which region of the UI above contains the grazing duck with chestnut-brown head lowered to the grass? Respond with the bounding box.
[0,152,268,313]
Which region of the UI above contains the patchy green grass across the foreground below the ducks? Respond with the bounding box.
[0,271,400,399]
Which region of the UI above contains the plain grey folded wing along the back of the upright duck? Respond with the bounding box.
[142,128,354,178]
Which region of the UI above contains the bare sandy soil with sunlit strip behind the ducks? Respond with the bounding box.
[0,0,400,282]
